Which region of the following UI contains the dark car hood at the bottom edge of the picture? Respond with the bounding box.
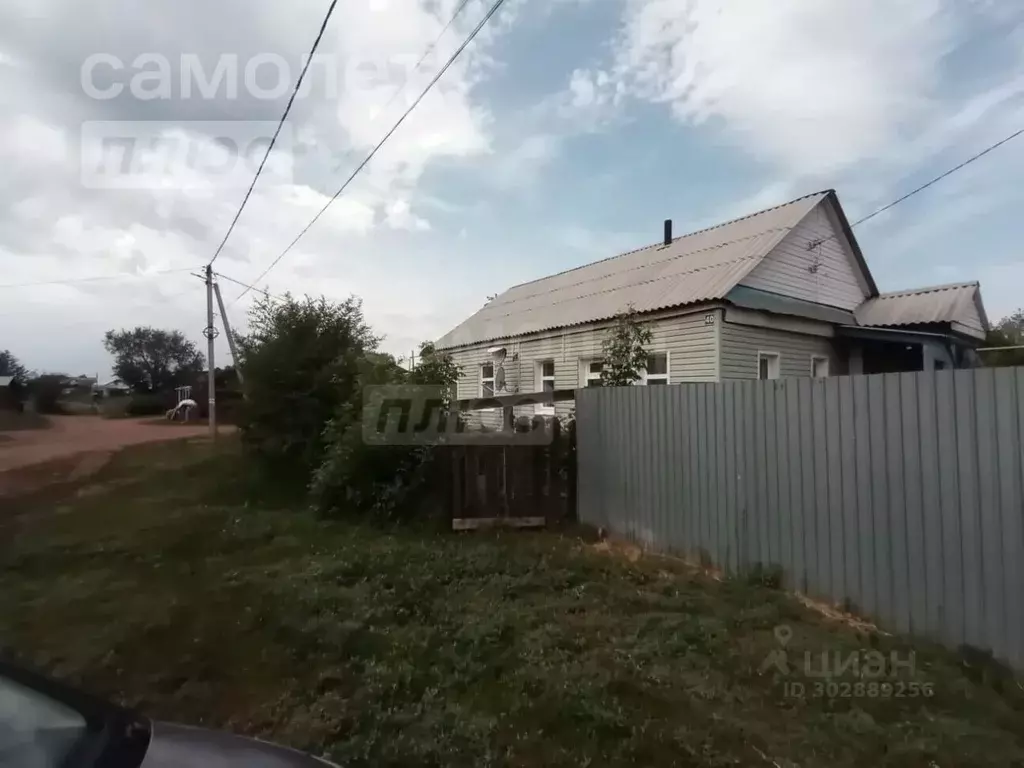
[140,722,332,768]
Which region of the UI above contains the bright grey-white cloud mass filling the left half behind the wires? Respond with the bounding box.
[0,0,517,370]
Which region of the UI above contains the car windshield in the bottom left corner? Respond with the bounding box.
[0,677,88,768]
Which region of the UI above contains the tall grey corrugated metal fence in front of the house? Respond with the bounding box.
[577,369,1024,669]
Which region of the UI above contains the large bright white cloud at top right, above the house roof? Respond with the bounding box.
[589,0,955,174]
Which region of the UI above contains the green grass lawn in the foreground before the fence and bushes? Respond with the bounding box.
[0,441,1024,766]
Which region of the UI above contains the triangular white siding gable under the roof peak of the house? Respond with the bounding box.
[740,202,867,310]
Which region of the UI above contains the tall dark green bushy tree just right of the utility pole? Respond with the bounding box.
[239,296,382,487]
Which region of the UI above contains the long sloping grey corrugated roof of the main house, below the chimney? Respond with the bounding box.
[437,191,828,349]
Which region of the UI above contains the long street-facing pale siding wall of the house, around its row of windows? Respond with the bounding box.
[452,309,722,426]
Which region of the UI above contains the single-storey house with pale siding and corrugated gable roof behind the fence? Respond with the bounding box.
[437,190,989,421]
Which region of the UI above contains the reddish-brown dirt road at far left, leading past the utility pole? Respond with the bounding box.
[0,416,207,497]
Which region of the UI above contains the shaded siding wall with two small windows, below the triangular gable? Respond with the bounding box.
[722,323,846,379]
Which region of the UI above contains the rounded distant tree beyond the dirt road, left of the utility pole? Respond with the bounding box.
[103,326,204,392]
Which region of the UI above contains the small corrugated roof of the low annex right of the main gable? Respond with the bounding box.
[854,283,990,338]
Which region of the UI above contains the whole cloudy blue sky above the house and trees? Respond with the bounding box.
[0,0,1024,377]
